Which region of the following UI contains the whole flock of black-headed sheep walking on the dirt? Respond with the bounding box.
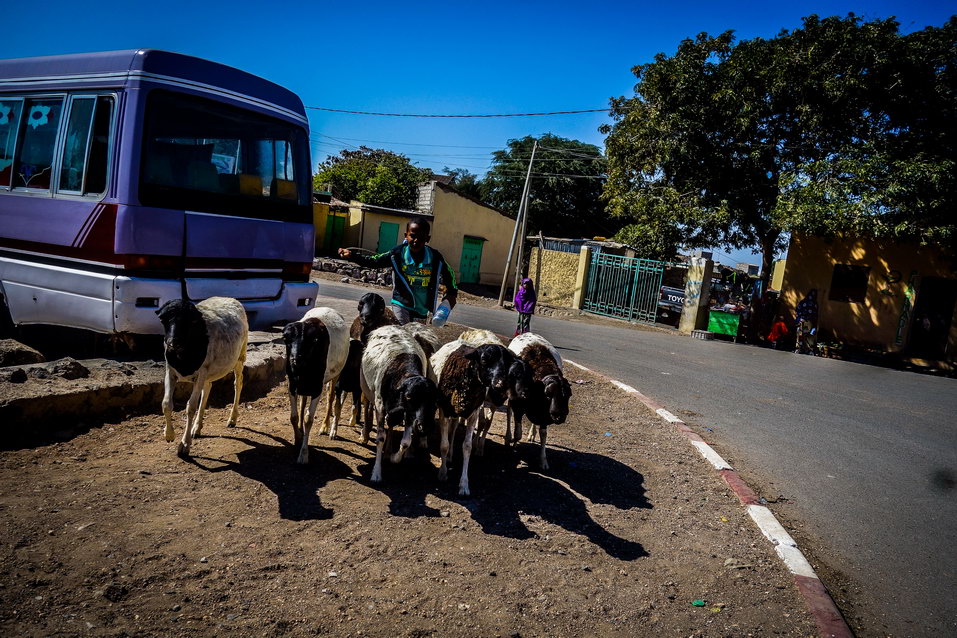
[157,293,571,496]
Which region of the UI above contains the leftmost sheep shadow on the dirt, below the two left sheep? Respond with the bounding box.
[185,428,352,521]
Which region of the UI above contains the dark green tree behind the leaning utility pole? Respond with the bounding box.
[482,133,619,237]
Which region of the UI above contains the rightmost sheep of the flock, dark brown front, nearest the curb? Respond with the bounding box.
[506,332,572,470]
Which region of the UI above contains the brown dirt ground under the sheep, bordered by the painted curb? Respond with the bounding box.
[0,316,816,637]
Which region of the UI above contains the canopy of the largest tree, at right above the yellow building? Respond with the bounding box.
[604,14,957,276]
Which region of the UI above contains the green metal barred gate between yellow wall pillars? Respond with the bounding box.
[582,252,672,323]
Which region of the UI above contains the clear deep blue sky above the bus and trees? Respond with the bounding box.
[0,0,957,261]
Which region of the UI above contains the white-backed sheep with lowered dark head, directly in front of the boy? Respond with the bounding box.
[360,326,437,483]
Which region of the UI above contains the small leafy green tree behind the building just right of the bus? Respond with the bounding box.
[313,146,432,209]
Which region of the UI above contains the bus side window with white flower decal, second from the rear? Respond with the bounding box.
[13,98,63,189]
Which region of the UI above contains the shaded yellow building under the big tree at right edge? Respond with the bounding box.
[781,234,957,363]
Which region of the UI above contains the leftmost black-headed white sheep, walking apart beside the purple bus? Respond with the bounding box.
[156,297,249,456]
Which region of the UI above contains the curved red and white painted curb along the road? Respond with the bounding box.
[565,359,854,638]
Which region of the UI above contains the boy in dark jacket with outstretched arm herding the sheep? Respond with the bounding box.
[339,217,459,324]
